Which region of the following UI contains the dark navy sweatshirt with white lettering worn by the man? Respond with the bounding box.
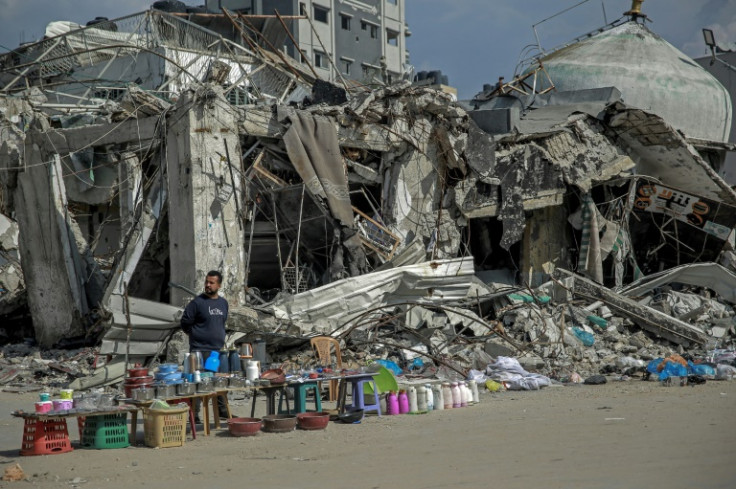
[181,294,228,351]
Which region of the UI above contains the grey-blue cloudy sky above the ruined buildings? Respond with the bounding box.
[0,0,736,98]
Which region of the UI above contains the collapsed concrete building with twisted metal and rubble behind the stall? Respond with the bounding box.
[0,1,736,386]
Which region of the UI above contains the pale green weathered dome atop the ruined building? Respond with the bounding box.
[542,22,731,142]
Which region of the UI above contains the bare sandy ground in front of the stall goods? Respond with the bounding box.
[0,380,736,489]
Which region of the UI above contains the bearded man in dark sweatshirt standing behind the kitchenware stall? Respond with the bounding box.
[180,270,228,418]
